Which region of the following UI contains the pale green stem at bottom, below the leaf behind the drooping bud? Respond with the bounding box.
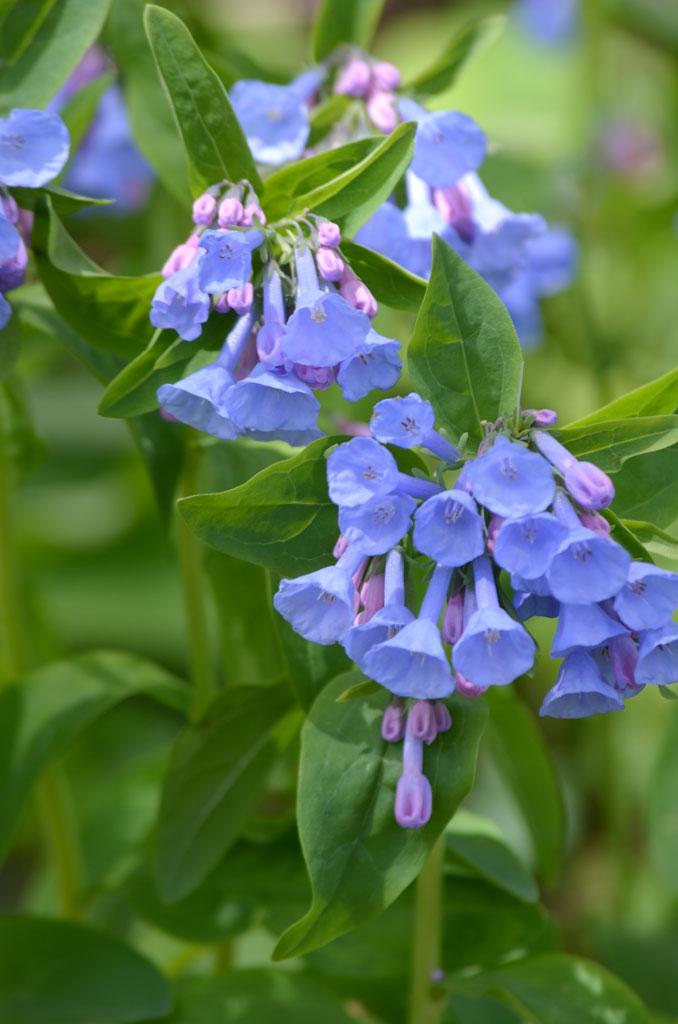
[409,836,444,1024]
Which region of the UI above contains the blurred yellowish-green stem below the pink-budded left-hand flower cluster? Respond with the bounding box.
[178,440,215,720]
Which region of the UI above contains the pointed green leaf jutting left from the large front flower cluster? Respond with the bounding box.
[178,437,339,577]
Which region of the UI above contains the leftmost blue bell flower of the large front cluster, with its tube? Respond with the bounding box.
[273,547,363,644]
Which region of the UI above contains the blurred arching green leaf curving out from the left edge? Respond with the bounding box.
[0,650,187,851]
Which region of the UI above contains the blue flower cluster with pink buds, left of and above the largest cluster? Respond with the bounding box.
[151,190,402,444]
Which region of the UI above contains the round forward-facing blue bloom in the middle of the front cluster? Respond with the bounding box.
[413,489,484,568]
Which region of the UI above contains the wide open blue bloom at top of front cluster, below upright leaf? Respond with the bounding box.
[465,436,555,519]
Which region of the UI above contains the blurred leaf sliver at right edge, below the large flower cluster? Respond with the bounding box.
[647,708,678,893]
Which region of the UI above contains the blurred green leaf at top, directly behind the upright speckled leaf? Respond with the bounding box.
[107,0,190,207]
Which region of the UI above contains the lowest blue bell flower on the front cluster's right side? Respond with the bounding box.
[539,650,624,718]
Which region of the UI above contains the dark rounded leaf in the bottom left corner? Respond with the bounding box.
[0,916,172,1024]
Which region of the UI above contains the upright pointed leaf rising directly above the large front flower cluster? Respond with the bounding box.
[408,234,522,440]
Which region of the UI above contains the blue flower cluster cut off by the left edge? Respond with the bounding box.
[0,110,70,330]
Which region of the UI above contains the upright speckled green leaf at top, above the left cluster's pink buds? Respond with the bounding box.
[143,4,261,196]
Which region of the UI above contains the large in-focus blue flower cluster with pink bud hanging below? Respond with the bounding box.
[273,394,678,826]
